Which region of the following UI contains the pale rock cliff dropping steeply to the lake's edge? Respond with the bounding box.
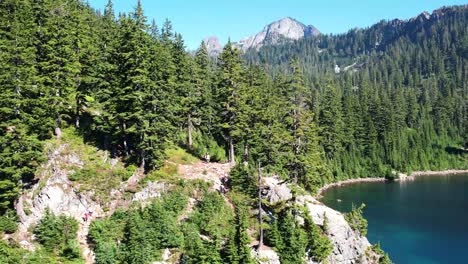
[264,178,375,264]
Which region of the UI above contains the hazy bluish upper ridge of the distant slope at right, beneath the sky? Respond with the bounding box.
[245,5,468,72]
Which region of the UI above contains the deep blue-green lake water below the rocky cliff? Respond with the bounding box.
[321,175,468,264]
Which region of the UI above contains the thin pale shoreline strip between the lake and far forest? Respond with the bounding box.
[314,170,468,199]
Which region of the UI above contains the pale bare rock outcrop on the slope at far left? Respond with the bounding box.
[16,144,103,263]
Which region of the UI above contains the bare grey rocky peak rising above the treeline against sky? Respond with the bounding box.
[236,17,320,50]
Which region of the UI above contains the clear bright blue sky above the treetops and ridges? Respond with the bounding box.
[88,0,466,49]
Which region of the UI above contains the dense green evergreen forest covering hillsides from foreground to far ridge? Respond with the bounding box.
[0,0,468,263]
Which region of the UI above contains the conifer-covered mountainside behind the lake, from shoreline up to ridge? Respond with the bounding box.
[244,6,468,179]
